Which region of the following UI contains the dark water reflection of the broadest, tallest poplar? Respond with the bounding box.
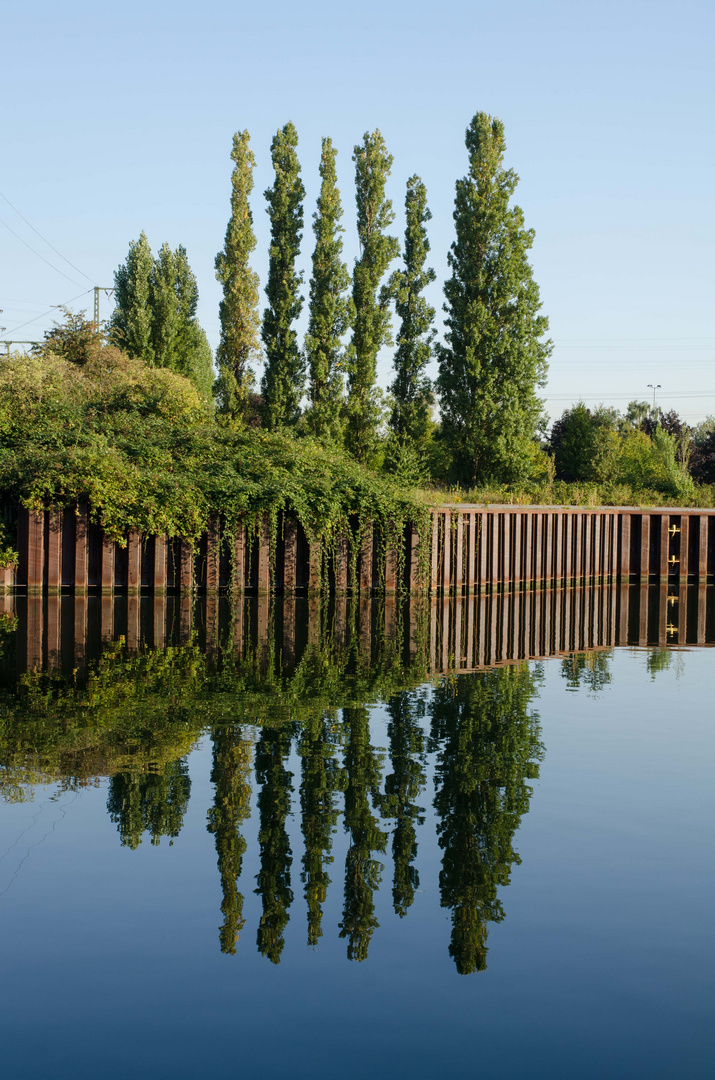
[432,665,542,975]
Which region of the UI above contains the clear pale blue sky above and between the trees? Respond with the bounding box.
[0,0,715,423]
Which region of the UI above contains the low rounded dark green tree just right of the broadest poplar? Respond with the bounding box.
[549,402,620,483]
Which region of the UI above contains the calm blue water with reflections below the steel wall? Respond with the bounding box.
[0,591,715,1080]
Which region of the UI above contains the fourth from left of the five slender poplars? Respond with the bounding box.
[346,131,400,464]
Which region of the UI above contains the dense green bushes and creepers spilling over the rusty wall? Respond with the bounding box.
[0,347,428,561]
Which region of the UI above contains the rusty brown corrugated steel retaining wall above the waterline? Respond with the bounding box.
[5,504,715,596]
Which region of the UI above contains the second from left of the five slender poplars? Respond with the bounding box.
[261,123,306,429]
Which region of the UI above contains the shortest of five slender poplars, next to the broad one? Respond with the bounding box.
[388,176,435,472]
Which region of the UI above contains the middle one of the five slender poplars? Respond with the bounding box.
[306,138,354,442]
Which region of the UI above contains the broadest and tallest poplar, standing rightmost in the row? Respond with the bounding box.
[437,112,552,484]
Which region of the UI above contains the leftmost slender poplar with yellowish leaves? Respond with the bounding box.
[215,131,260,426]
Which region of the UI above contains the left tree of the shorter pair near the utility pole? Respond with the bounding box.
[109,230,154,366]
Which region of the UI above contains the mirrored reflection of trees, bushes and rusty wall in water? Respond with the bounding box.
[0,589,712,974]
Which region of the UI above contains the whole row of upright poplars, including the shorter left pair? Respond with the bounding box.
[110,112,551,484]
